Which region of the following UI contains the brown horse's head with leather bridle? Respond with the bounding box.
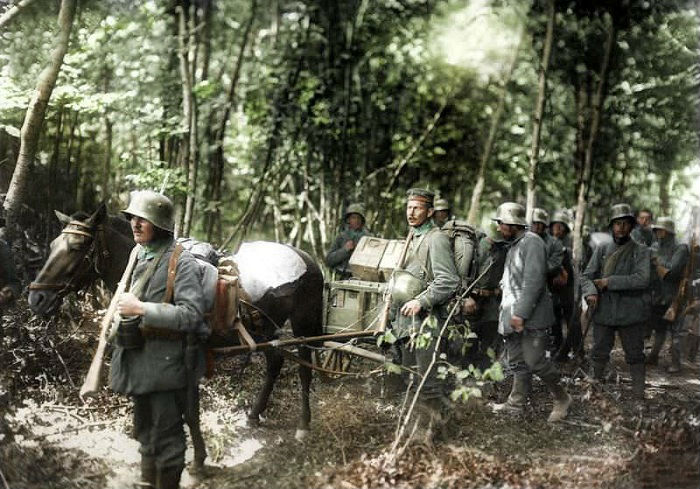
[29,204,109,316]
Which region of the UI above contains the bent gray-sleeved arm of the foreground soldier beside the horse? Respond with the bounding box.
[143,252,204,333]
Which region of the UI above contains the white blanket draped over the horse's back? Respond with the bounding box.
[233,241,306,302]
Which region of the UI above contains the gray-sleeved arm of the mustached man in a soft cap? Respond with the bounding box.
[417,233,459,310]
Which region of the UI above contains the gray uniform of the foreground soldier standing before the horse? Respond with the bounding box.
[110,240,208,469]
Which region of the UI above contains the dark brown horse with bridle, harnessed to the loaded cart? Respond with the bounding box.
[29,203,323,464]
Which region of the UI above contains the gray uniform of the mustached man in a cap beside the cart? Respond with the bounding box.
[393,220,460,399]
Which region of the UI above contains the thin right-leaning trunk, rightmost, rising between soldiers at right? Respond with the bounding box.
[573,15,617,269]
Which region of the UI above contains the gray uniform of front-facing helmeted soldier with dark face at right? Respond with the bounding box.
[581,239,650,366]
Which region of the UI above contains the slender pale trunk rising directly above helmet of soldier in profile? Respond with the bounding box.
[527,0,554,221]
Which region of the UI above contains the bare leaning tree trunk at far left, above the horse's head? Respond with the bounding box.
[4,0,77,237]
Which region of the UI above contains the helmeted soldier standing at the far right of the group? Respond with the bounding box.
[646,217,689,373]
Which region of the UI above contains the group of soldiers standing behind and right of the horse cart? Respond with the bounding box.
[326,188,698,432]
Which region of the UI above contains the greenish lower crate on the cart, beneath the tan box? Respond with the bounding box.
[324,279,385,334]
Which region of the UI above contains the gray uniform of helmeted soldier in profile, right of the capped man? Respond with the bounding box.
[498,231,559,386]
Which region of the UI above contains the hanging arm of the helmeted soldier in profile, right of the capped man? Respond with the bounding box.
[513,234,547,319]
